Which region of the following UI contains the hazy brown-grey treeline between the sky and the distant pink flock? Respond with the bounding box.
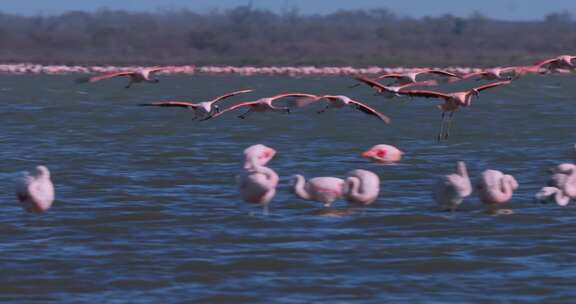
[0,6,576,68]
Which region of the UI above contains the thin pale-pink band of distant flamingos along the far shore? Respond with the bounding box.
[0,63,481,77]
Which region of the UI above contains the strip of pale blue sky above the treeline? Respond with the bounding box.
[0,0,576,20]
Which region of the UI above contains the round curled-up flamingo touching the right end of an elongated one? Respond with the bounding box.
[344,169,380,206]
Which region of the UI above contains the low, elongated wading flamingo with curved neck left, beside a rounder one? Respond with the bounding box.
[292,174,345,207]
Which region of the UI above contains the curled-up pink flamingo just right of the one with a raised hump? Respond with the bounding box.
[476,169,518,214]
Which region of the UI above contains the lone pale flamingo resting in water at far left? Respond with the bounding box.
[16,166,54,213]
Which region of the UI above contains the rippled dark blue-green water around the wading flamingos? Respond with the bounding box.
[0,76,576,303]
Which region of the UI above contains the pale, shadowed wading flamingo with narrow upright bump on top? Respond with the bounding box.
[432,161,472,212]
